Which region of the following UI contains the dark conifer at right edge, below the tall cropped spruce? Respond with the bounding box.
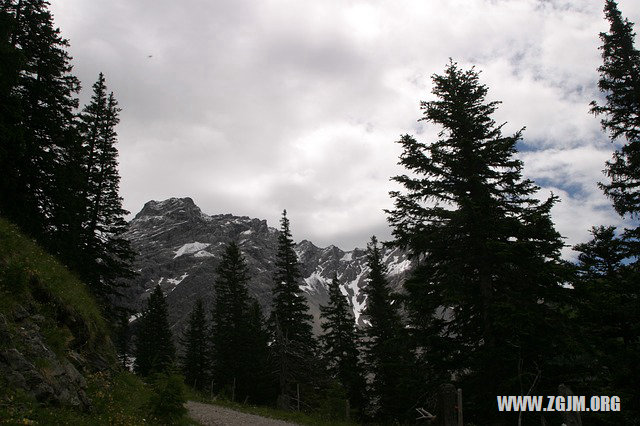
[574,226,640,424]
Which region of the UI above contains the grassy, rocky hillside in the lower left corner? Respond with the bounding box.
[0,218,182,425]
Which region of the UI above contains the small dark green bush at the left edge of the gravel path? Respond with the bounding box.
[150,373,187,423]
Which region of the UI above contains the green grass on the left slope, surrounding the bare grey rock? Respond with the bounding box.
[0,218,193,425]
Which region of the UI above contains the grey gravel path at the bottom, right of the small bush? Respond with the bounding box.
[186,401,295,426]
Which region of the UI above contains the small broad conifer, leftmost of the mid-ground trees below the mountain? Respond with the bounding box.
[134,285,176,376]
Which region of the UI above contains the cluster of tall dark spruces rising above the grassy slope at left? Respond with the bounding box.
[0,0,133,316]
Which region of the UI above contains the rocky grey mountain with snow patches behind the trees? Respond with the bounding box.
[122,198,411,335]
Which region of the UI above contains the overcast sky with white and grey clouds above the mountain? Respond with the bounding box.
[51,0,640,256]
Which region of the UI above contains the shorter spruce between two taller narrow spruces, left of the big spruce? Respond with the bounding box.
[320,275,366,416]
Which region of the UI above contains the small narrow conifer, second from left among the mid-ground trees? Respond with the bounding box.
[181,299,211,390]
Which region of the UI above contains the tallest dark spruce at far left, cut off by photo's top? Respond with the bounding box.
[0,0,80,248]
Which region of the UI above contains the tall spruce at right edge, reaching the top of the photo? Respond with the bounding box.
[591,0,640,230]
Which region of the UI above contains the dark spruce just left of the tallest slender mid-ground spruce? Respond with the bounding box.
[212,242,268,401]
